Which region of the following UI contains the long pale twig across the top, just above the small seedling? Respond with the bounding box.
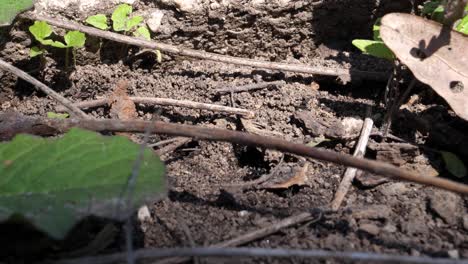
[21,12,388,80]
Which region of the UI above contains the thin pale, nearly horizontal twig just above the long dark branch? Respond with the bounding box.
[56,97,255,118]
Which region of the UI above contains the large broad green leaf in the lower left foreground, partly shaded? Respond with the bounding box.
[0,128,166,239]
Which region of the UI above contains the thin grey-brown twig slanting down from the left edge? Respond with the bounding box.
[0,59,89,118]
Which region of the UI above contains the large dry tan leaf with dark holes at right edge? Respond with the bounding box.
[380,13,468,120]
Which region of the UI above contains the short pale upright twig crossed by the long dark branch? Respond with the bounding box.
[331,117,374,210]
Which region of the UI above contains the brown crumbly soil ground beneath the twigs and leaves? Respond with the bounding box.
[0,0,468,263]
